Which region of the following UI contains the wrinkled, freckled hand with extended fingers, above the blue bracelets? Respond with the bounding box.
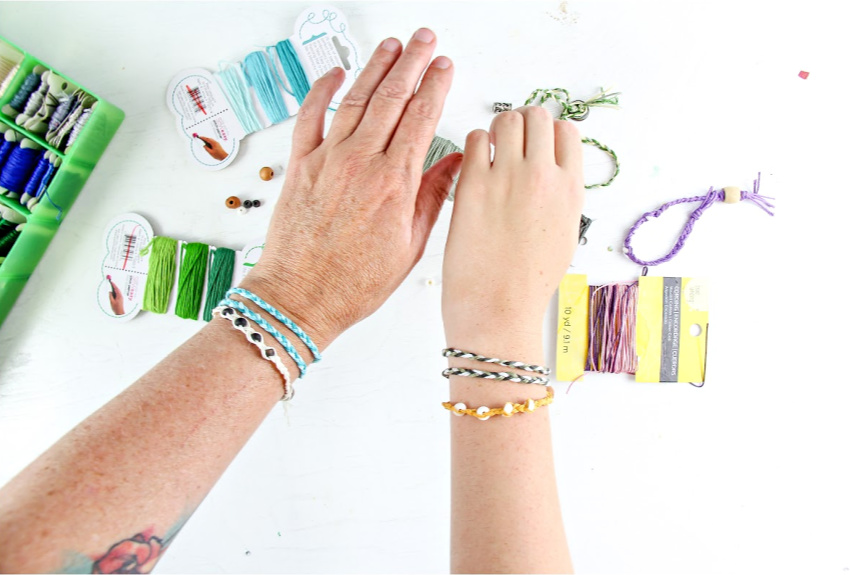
[242,28,462,348]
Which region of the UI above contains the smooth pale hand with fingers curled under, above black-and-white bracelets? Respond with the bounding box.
[443,107,584,352]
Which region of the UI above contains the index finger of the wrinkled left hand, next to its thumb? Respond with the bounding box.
[387,56,454,166]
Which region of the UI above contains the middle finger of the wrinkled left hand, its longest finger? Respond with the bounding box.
[356,28,436,150]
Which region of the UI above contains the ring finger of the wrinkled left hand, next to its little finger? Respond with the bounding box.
[328,38,401,142]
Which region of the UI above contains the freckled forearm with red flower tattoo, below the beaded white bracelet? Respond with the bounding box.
[0,320,286,572]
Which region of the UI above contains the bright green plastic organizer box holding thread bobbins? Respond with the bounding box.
[0,36,124,325]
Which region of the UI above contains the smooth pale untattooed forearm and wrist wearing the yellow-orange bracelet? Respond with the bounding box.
[448,322,572,573]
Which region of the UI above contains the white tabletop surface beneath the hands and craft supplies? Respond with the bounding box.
[0,1,850,574]
